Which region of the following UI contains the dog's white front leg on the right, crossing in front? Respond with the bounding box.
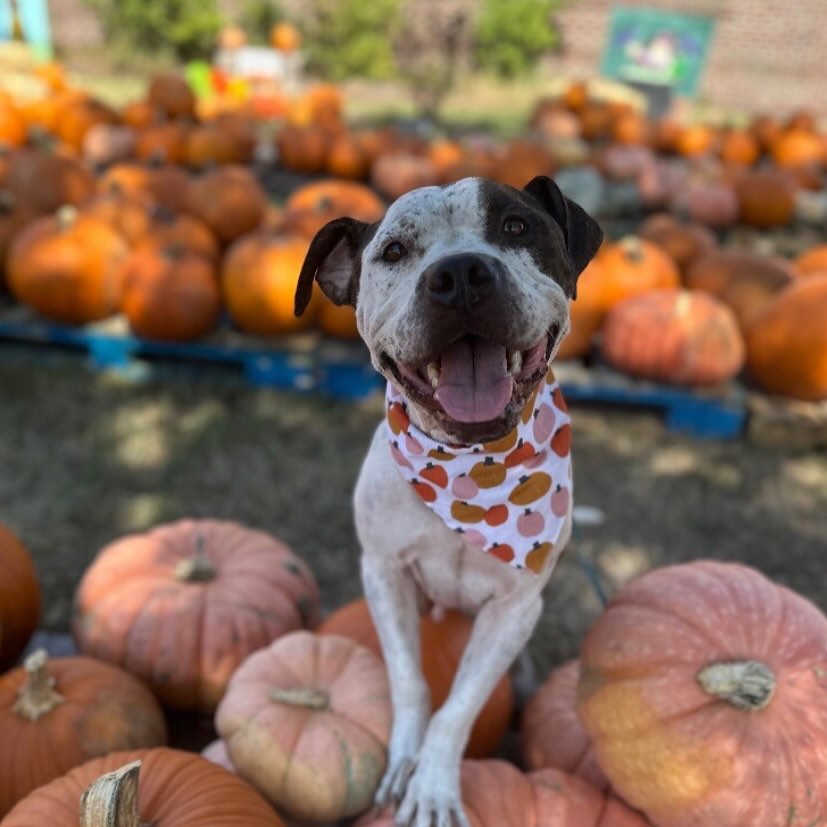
[396,589,542,827]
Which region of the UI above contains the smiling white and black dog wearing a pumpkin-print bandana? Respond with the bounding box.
[295,176,603,827]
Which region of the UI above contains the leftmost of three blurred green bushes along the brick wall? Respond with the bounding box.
[86,0,222,60]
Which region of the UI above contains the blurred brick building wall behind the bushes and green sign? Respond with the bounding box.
[49,0,827,115]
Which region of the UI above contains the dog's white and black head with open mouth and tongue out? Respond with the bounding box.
[296,177,602,444]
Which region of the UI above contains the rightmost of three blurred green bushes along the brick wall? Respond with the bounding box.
[474,0,561,78]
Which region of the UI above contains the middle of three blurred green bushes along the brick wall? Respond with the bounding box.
[303,0,400,82]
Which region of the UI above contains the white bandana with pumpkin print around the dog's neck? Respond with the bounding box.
[387,369,572,573]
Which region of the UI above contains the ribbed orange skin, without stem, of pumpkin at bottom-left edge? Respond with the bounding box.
[3,748,284,827]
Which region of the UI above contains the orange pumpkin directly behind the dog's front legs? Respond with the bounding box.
[319,600,513,758]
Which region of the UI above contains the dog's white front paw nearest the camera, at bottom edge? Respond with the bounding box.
[394,764,470,827]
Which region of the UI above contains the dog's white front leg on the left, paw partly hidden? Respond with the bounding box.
[362,555,431,806]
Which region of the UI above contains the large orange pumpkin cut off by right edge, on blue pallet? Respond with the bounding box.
[746,274,827,400]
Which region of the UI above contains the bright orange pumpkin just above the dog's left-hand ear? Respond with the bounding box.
[284,179,385,239]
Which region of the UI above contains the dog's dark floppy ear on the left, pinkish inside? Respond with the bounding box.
[294,218,371,316]
